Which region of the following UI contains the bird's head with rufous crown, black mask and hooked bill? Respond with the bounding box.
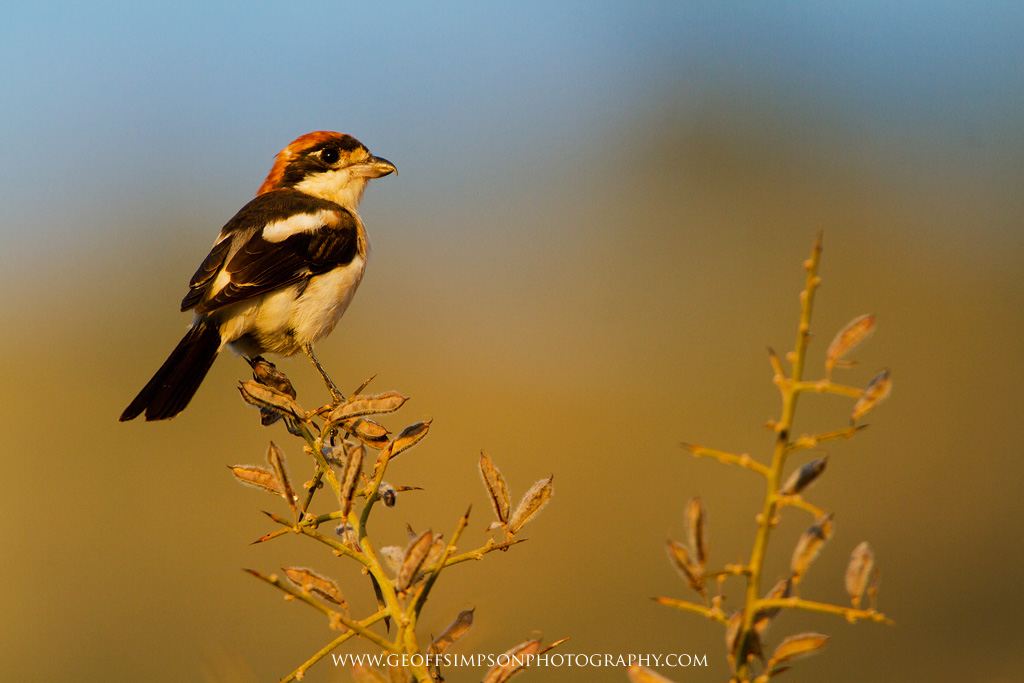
[256,130,397,211]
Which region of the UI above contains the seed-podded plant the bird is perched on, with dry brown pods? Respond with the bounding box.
[230,366,557,683]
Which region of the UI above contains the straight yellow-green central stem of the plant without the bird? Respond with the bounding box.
[736,232,821,680]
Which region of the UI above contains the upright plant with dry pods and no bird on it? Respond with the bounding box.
[655,232,893,683]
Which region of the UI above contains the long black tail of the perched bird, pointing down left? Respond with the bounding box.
[121,321,220,422]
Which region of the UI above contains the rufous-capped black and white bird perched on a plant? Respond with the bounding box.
[120,130,397,422]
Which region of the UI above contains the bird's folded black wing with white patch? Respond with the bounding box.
[181,189,358,313]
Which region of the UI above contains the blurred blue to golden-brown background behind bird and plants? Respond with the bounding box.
[0,2,1024,682]
